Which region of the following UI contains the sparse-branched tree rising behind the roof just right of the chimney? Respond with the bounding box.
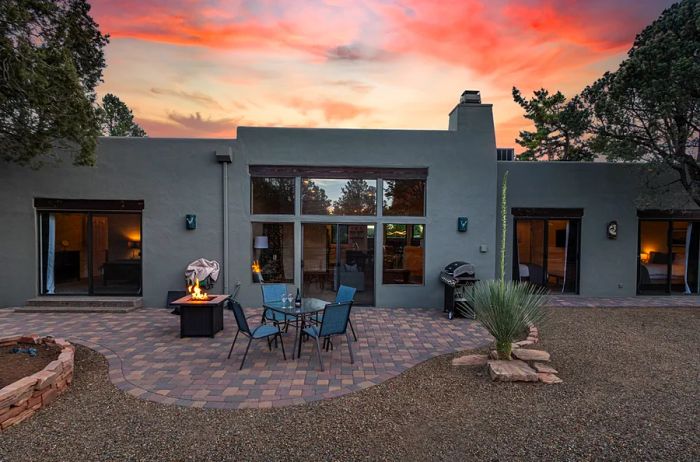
[513,87,594,161]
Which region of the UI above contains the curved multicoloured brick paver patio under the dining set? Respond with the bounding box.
[0,307,490,409]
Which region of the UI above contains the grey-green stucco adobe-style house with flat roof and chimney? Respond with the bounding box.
[0,92,700,307]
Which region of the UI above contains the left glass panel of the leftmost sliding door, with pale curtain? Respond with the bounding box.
[40,212,90,295]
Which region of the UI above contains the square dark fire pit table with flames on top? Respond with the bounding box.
[172,295,230,338]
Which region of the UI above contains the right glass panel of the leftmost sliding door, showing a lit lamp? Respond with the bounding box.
[92,213,141,295]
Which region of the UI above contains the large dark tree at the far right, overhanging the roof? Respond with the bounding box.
[583,0,700,205]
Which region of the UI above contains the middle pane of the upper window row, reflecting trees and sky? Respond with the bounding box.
[301,178,377,216]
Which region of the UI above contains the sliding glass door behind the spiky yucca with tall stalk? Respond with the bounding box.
[513,218,581,293]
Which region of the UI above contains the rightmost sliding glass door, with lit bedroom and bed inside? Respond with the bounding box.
[637,220,700,294]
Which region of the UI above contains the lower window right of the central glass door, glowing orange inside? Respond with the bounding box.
[382,224,425,284]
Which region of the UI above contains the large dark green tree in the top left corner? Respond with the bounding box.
[0,0,108,167]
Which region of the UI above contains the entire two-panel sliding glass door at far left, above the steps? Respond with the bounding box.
[39,211,141,295]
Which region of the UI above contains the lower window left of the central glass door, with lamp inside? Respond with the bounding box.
[253,223,294,283]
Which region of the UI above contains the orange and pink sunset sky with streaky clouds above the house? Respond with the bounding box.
[90,0,673,147]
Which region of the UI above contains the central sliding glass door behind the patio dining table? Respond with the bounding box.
[302,223,375,305]
